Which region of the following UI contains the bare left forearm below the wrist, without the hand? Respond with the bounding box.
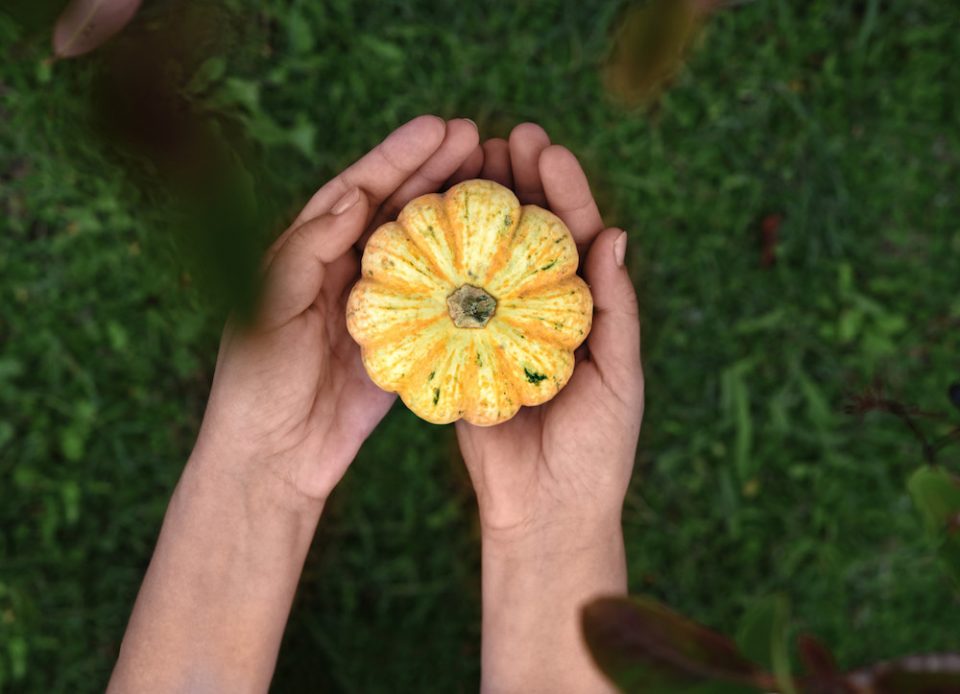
[109,459,321,693]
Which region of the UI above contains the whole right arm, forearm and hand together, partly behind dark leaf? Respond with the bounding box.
[456,123,644,692]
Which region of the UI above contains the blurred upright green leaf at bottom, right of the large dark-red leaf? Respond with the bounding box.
[735,595,795,694]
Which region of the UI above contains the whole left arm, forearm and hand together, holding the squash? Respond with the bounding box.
[108,116,482,692]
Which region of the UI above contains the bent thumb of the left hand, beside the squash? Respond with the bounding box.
[258,188,369,329]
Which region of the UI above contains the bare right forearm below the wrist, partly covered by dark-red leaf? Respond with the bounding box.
[482,521,627,694]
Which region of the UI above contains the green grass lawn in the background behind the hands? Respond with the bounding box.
[0,0,960,692]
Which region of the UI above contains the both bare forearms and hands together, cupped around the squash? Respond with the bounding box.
[108,116,642,693]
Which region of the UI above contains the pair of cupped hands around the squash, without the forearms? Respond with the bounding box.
[197,116,643,542]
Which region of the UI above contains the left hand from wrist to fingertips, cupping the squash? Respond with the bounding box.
[194,116,482,502]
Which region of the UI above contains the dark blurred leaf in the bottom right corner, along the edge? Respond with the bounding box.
[847,653,960,694]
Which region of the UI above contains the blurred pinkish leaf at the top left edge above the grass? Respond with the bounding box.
[53,0,140,58]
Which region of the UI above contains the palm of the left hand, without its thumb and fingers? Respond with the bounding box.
[197,260,393,493]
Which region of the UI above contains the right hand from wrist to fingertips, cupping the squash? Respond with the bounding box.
[457,128,643,543]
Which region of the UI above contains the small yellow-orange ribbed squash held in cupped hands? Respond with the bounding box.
[347,180,593,425]
